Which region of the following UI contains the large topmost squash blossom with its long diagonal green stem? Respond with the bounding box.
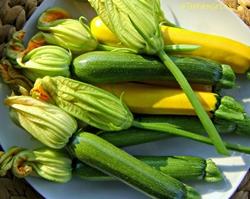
[88,0,229,155]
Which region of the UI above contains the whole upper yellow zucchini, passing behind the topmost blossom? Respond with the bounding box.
[91,17,250,73]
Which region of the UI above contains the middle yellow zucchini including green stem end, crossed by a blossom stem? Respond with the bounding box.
[98,83,245,121]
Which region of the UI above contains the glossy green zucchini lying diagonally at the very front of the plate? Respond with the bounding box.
[68,132,200,199]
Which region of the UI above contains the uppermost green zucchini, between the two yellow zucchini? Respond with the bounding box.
[73,51,235,88]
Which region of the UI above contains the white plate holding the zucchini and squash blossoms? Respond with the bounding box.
[0,0,250,199]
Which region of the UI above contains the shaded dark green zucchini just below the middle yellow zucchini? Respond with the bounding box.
[97,115,250,147]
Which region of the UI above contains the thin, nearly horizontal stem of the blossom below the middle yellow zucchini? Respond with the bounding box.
[133,120,250,154]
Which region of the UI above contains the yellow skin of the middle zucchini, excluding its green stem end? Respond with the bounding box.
[98,83,218,115]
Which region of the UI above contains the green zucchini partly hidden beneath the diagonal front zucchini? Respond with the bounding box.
[73,156,223,182]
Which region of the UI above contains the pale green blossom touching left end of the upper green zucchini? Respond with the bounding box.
[17,45,72,81]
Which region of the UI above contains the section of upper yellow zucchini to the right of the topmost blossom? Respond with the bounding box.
[161,26,250,73]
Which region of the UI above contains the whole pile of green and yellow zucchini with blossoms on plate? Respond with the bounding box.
[0,0,250,199]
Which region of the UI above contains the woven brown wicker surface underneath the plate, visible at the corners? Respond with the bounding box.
[0,0,250,199]
